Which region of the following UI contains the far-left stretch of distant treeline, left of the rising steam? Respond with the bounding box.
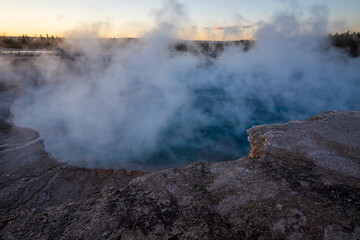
[0,34,63,49]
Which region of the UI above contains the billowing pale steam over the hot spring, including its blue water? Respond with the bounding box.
[4,2,360,169]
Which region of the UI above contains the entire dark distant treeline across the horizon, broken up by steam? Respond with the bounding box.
[0,32,360,57]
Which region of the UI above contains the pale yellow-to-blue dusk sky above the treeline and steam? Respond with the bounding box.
[0,0,360,40]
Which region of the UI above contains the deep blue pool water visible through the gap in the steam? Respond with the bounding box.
[130,88,288,169]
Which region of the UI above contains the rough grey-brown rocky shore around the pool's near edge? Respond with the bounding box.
[0,111,360,239]
